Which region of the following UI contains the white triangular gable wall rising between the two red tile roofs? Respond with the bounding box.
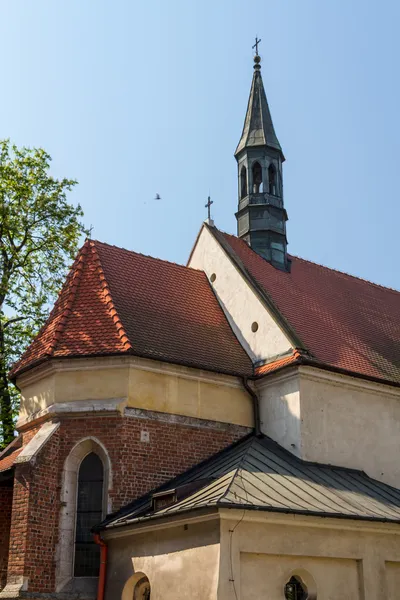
[189,227,291,361]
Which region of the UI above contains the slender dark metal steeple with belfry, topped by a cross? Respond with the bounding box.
[235,47,290,271]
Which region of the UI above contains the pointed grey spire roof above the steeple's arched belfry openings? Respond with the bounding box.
[235,55,284,158]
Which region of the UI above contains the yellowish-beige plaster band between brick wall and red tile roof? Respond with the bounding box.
[18,358,253,427]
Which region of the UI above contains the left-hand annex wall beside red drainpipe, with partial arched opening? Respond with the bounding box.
[105,520,219,600]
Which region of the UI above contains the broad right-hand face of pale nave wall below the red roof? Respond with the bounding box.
[300,367,400,488]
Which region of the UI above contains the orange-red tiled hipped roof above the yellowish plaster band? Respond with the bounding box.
[10,240,252,378]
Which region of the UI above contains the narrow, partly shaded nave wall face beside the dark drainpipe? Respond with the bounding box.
[257,372,301,457]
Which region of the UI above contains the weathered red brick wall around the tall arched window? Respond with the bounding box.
[2,415,245,593]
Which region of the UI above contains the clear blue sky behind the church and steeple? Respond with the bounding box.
[0,0,400,288]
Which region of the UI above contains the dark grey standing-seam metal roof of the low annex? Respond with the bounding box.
[102,435,400,528]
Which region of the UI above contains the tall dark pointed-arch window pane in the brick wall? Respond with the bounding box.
[74,452,104,577]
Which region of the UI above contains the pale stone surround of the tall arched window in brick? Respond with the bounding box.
[56,436,112,592]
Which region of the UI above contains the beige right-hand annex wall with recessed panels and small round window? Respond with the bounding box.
[218,511,400,600]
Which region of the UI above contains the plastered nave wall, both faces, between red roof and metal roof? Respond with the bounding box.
[257,367,400,488]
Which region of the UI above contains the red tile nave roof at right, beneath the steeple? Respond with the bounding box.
[217,228,400,384]
